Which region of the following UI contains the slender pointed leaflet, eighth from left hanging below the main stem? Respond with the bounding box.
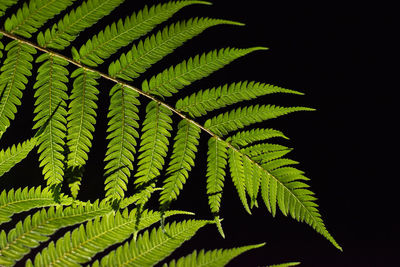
[228,149,252,214]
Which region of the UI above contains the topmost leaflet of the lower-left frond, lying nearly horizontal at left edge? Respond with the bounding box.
[0,186,72,225]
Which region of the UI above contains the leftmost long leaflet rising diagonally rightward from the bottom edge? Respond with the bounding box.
[27,209,191,266]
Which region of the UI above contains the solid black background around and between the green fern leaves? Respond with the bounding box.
[0,0,399,266]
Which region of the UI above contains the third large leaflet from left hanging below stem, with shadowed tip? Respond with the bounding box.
[67,68,100,197]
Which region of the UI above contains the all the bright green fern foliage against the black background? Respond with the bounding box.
[0,0,341,266]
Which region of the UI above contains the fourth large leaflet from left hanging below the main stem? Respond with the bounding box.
[104,84,140,199]
